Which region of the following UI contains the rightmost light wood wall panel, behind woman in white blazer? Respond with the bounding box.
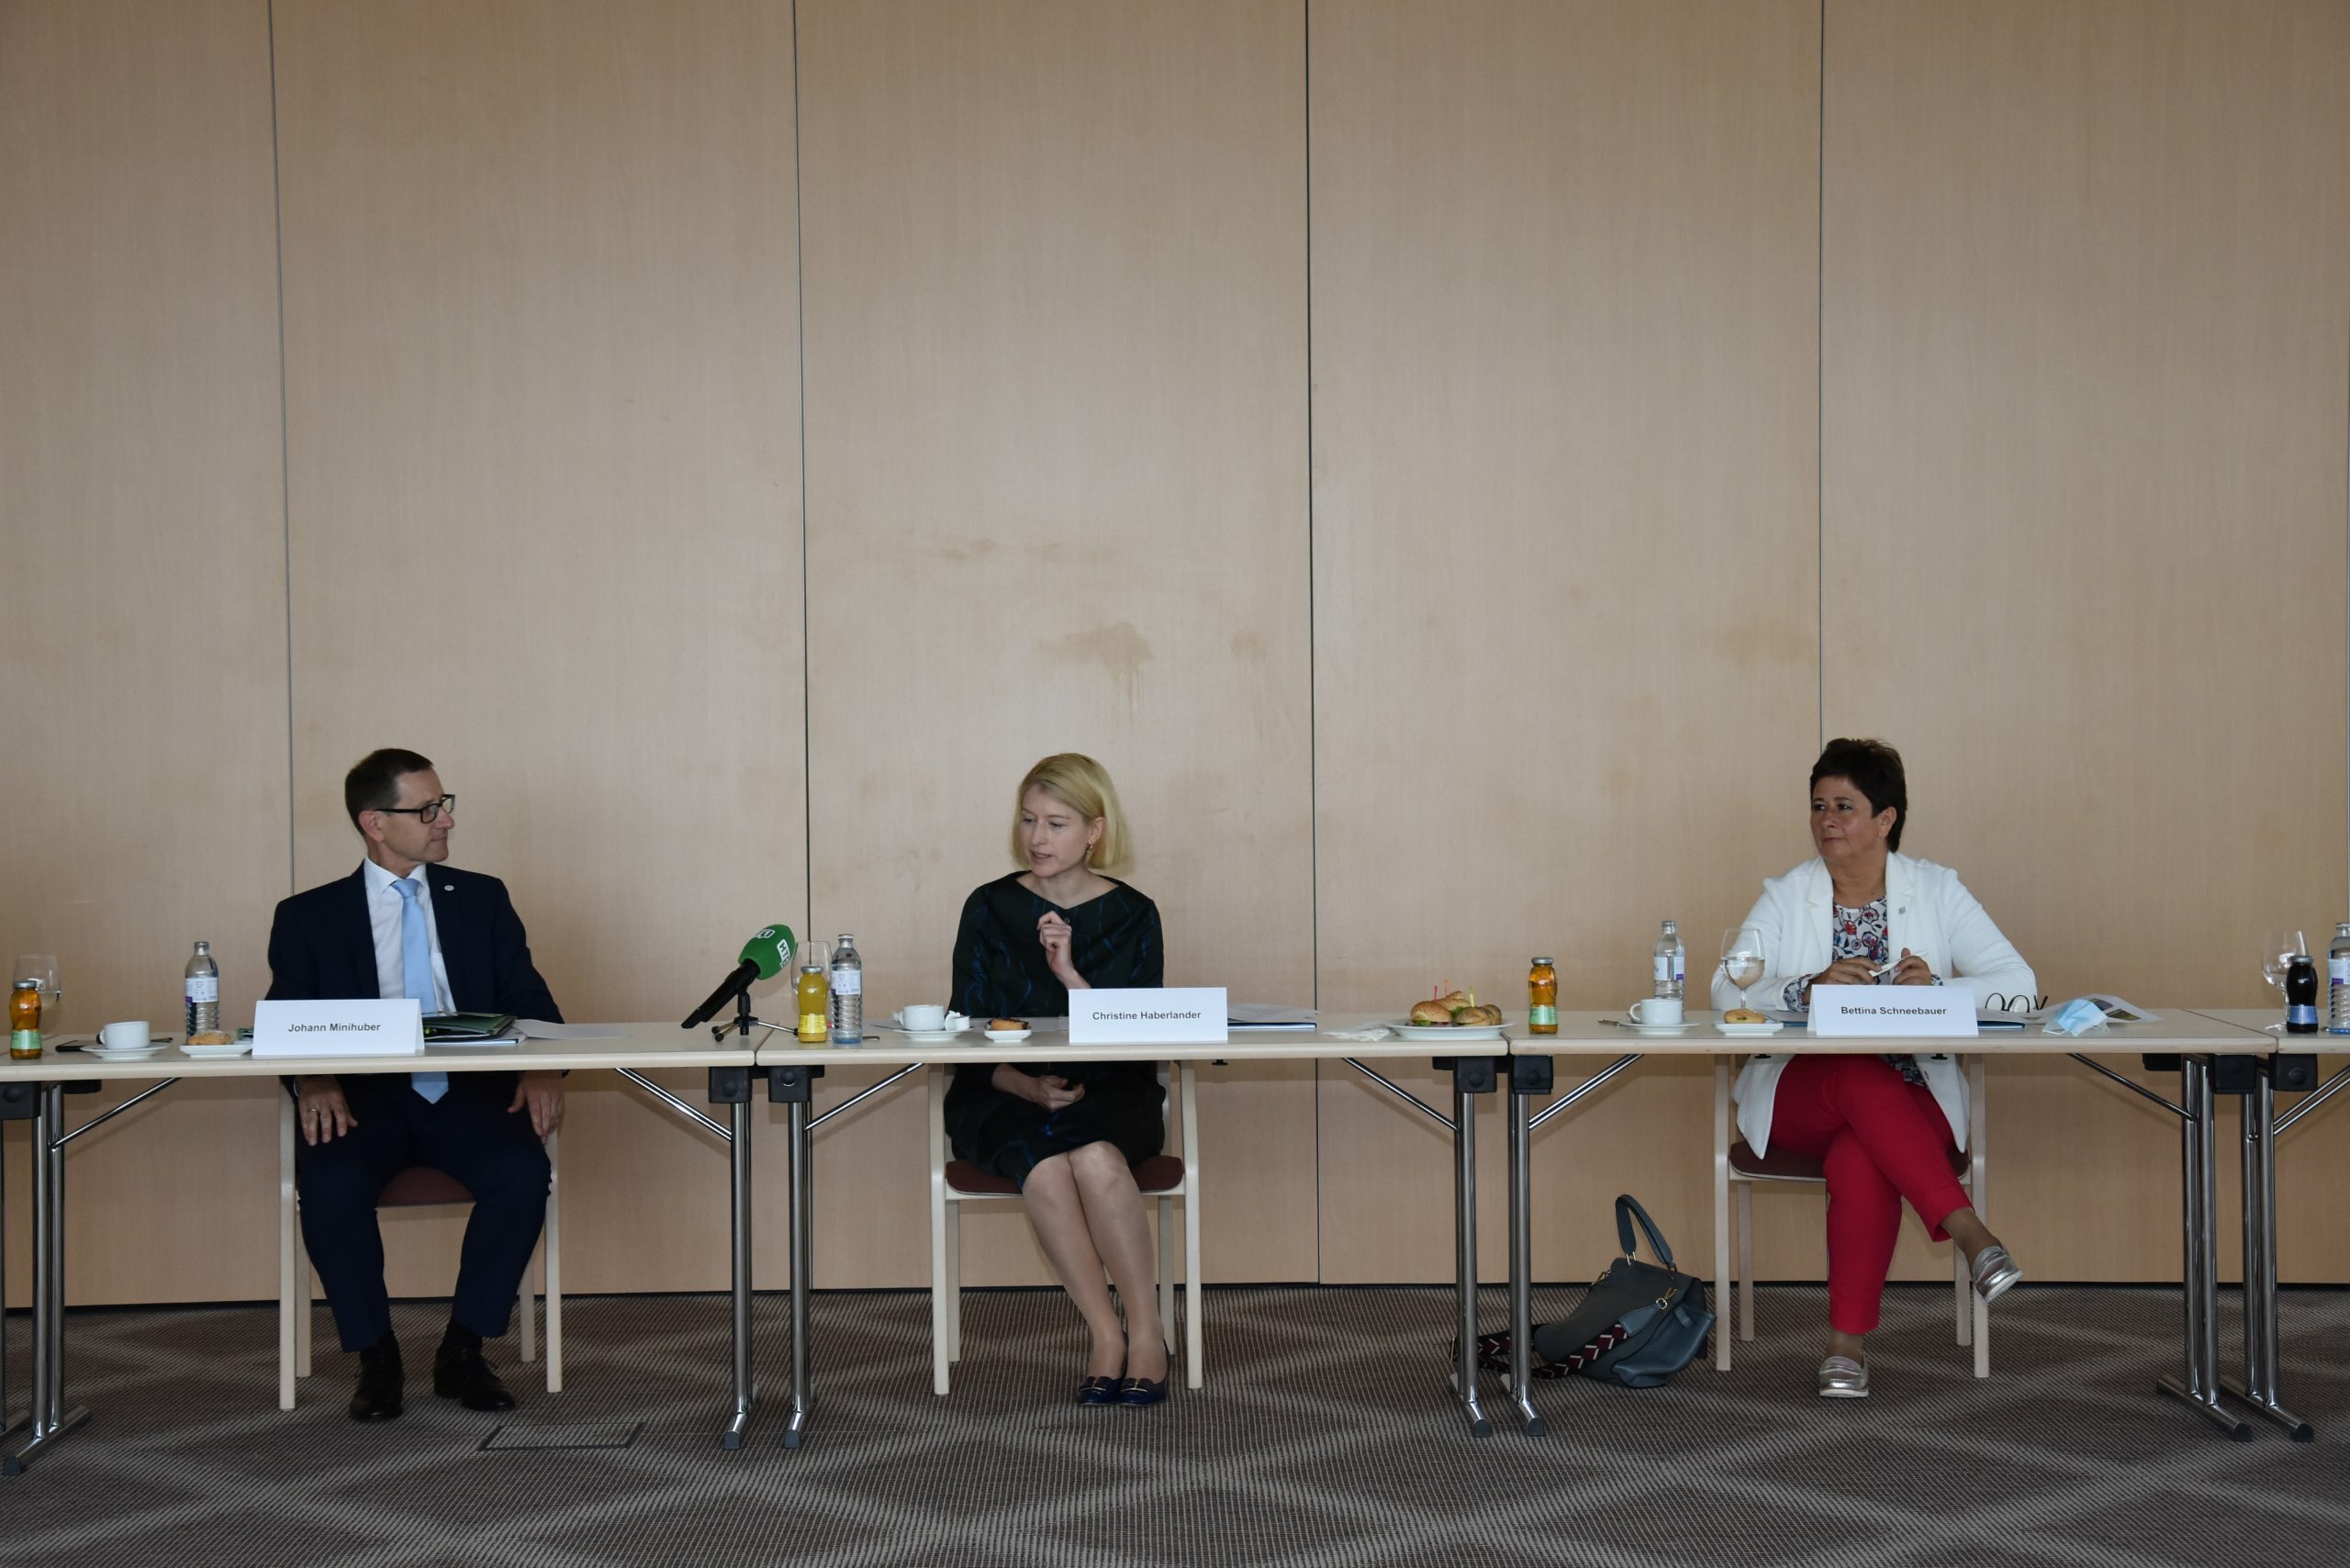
[1814,0,2350,1279]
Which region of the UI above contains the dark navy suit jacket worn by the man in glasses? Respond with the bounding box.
[270,865,564,1105]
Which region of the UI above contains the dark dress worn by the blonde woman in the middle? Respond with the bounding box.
[947,872,1166,1187]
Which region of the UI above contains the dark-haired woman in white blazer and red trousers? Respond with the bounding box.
[1713,738,2035,1399]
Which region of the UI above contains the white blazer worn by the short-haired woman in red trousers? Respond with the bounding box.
[1713,854,2038,1154]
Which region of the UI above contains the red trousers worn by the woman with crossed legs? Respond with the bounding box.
[1770,1056,1967,1333]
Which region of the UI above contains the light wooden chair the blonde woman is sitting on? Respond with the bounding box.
[928,1062,1201,1394]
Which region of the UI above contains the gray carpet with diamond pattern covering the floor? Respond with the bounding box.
[0,1286,2350,1568]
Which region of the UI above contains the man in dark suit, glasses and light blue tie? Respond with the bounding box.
[270,750,564,1420]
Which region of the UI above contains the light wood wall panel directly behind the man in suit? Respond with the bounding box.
[277,0,806,1293]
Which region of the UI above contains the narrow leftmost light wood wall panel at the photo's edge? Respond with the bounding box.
[0,0,286,1303]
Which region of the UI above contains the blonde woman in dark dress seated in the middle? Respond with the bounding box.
[947,752,1168,1406]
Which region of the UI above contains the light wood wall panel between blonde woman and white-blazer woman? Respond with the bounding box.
[1311,0,1818,1279]
